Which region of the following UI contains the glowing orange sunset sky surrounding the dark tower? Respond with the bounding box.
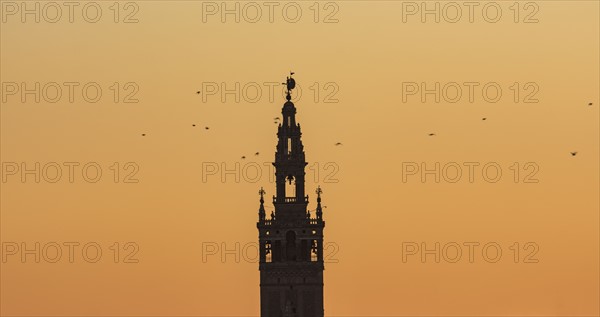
[0,0,600,316]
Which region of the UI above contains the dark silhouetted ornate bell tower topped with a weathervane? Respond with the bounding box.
[257,73,325,317]
